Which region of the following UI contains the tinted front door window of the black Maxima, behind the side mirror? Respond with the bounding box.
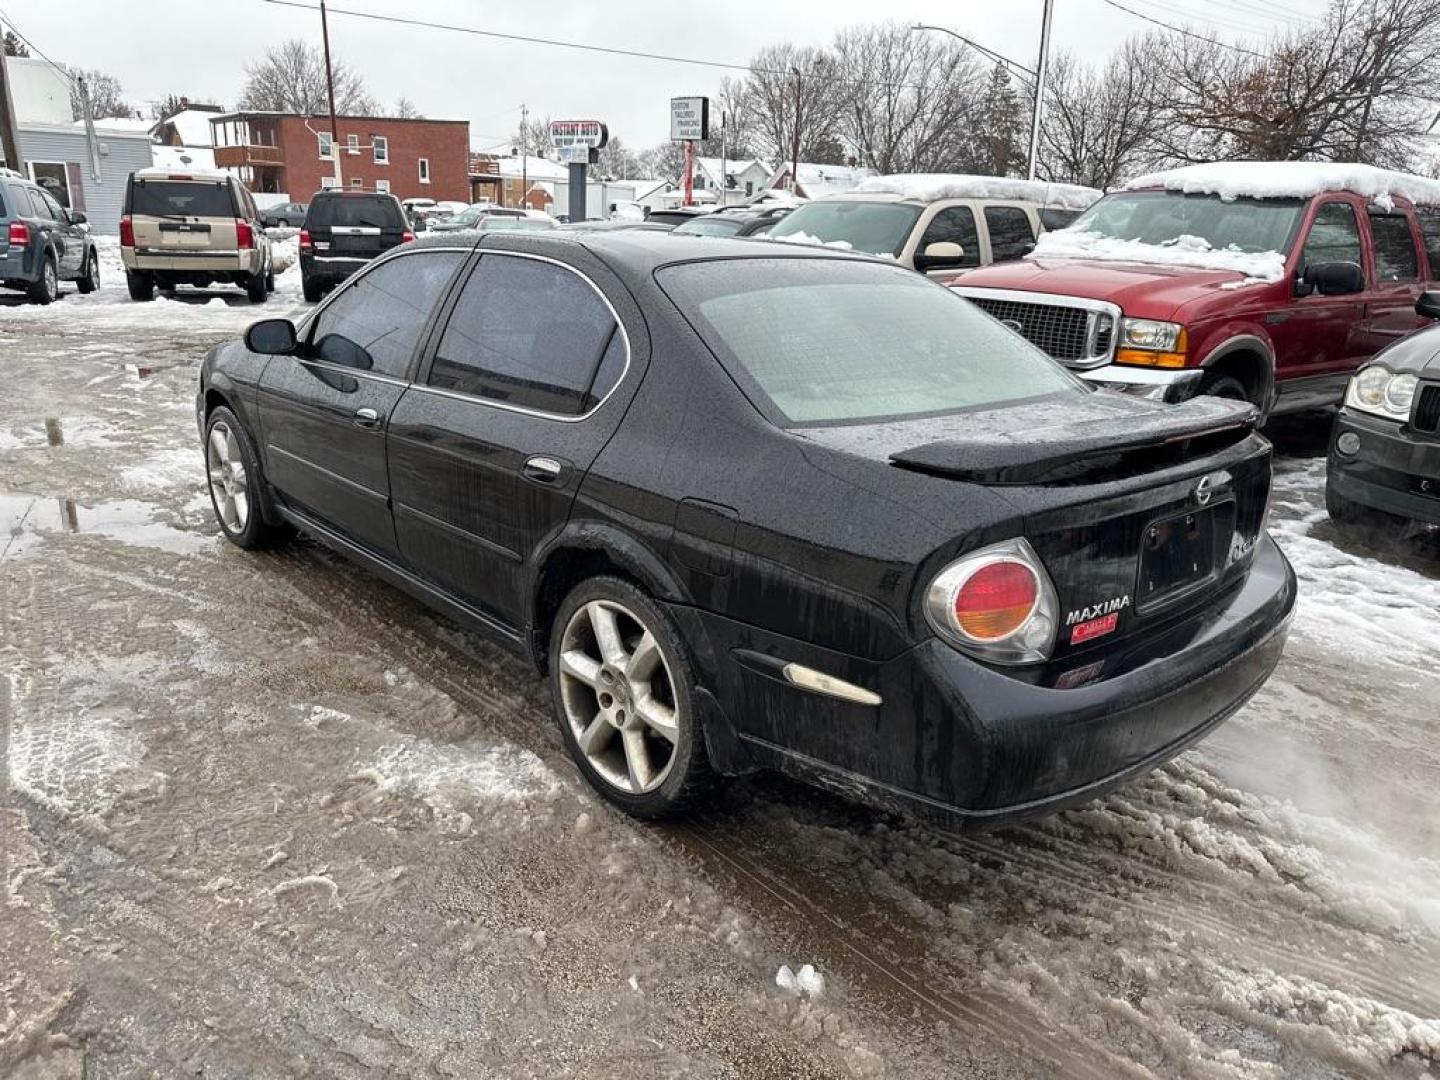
[310,251,465,379]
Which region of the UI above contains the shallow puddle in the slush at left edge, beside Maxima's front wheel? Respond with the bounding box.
[0,492,215,559]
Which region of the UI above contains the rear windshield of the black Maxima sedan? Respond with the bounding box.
[657,259,1084,425]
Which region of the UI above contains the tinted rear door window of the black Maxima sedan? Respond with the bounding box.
[429,255,626,416]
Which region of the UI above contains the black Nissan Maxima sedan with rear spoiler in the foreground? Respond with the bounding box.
[197,232,1295,827]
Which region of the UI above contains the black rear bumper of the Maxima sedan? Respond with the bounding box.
[683,536,1296,828]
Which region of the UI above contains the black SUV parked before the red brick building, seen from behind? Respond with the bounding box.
[300,192,415,302]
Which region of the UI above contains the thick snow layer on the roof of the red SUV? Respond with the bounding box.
[1125,161,1440,210]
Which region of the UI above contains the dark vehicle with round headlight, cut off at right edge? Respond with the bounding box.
[1325,292,1440,538]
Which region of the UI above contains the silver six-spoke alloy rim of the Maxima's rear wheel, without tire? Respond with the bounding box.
[557,600,681,795]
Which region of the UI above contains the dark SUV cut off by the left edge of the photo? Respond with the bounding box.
[0,168,99,304]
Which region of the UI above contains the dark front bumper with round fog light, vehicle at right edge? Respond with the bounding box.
[1325,409,1440,524]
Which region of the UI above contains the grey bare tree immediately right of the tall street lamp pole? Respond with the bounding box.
[1038,40,1165,190]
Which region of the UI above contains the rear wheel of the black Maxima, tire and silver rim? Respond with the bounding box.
[550,577,714,818]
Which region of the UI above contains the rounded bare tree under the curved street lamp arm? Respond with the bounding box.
[835,23,979,173]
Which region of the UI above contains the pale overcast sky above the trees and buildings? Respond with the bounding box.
[0,0,1323,150]
